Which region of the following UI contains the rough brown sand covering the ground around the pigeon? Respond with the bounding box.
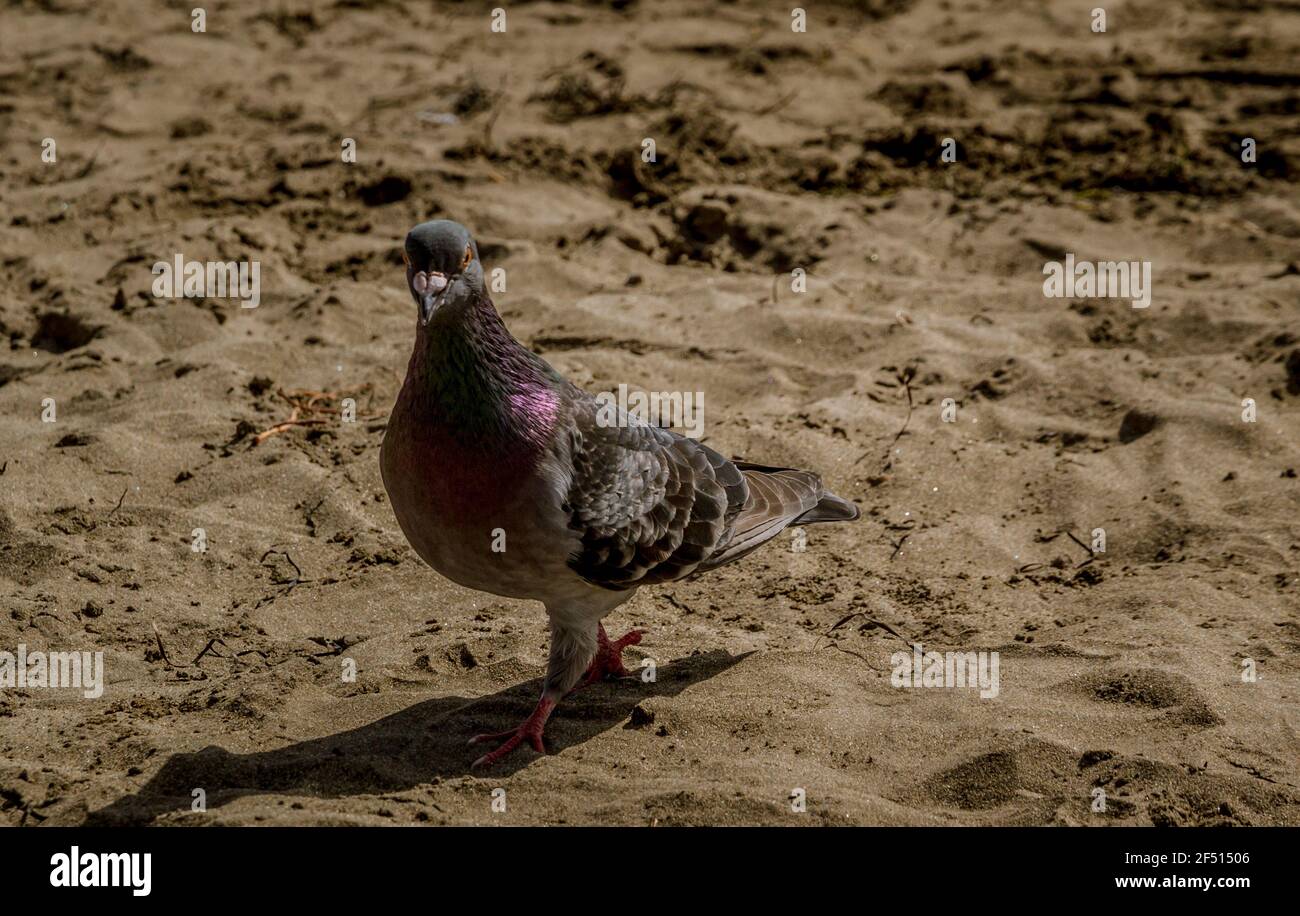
[0,0,1300,825]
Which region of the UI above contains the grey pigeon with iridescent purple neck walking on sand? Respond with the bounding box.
[380,220,859,767]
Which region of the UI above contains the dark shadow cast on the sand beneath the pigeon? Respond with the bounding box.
[82,650,750,826]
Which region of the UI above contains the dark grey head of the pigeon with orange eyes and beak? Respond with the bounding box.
[402,220,484,325]
